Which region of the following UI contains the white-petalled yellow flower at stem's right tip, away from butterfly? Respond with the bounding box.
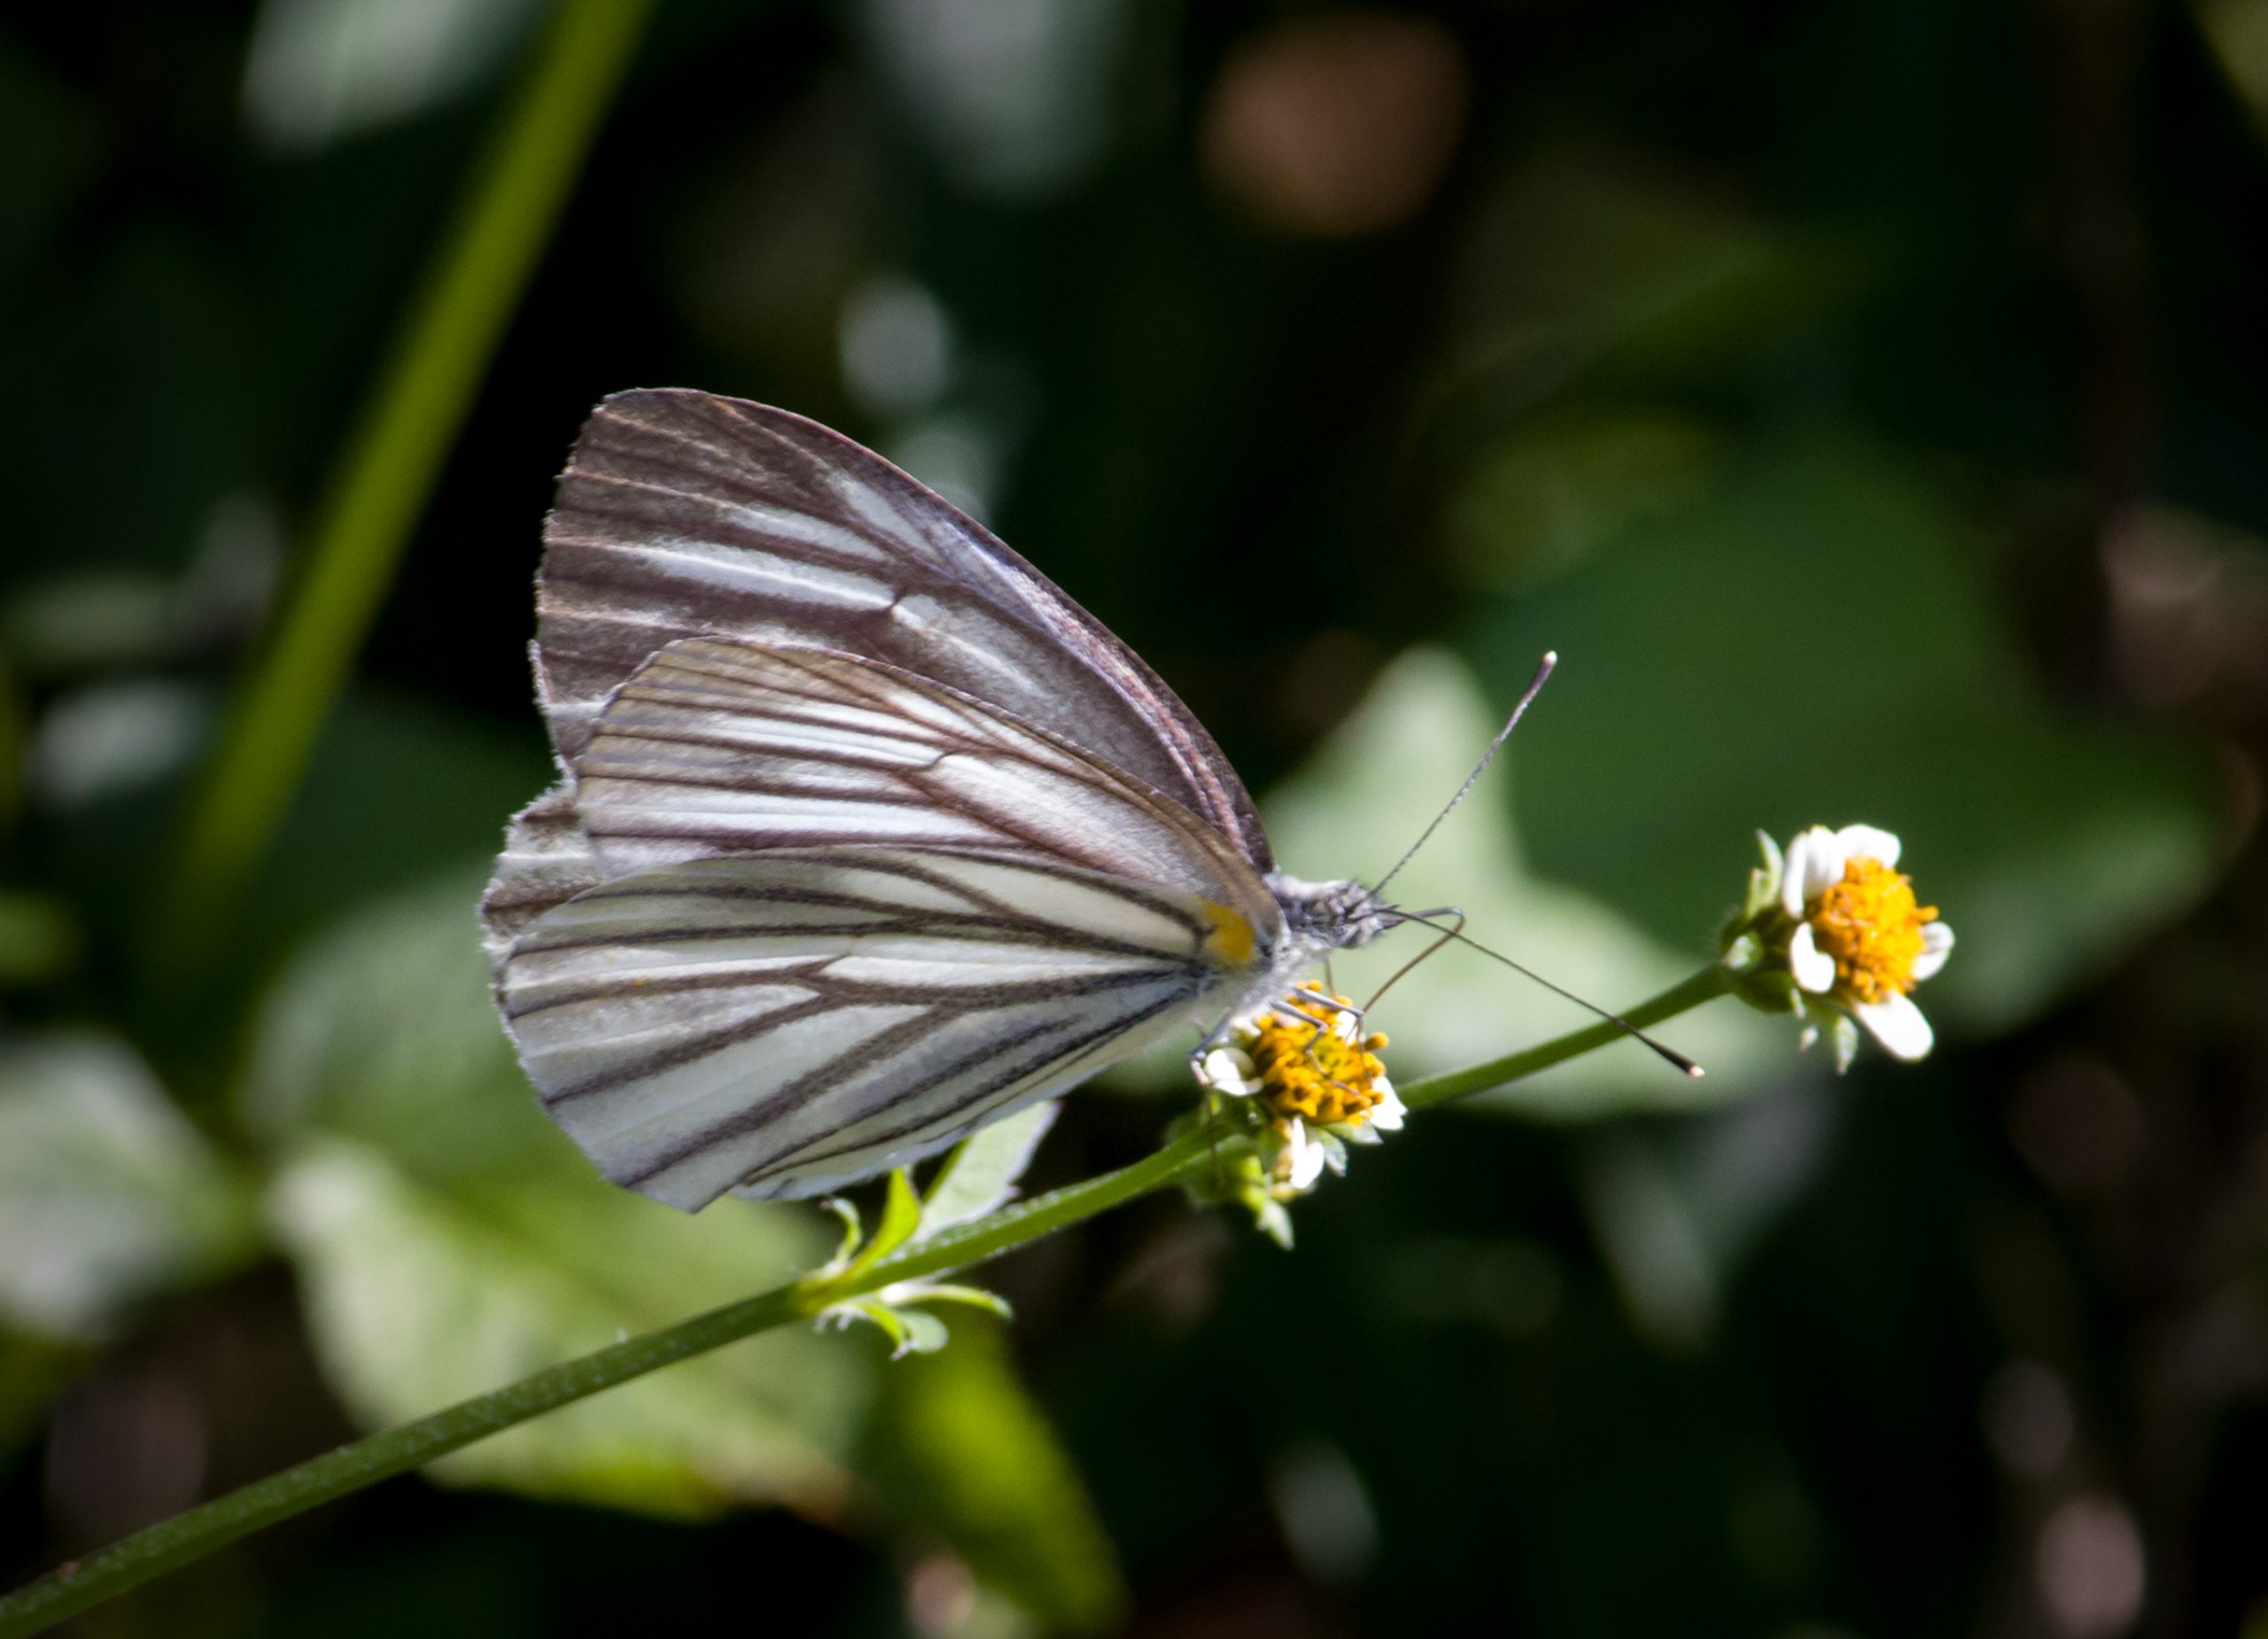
[1778,825,1953,1068]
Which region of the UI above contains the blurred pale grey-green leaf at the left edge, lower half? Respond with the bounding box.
[0,1031,259,1340]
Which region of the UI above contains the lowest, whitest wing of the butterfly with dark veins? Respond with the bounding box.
[499,845,1254,1210]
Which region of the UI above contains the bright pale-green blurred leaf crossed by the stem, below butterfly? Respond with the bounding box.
[270,1138,871,1517]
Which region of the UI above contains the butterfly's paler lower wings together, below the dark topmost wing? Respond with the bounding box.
[490,640,1281,1208]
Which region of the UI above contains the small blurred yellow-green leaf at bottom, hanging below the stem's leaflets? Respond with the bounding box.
[864,1315,1125,1632]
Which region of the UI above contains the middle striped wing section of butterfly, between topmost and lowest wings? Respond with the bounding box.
[574,640,1275,920]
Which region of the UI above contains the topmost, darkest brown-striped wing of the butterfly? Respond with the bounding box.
[535,390,1272,873]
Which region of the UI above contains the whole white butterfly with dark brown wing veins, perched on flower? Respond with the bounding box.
[481,390,1400,1210]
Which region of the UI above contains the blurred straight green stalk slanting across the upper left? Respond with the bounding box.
[157,0,653,973]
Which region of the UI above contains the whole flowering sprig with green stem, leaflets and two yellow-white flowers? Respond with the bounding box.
[0,825,1951,1639]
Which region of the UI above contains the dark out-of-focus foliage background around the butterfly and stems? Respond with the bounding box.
[0,0,2268,1639]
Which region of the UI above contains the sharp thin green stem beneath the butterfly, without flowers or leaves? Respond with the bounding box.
[0,968,1726,1639]
